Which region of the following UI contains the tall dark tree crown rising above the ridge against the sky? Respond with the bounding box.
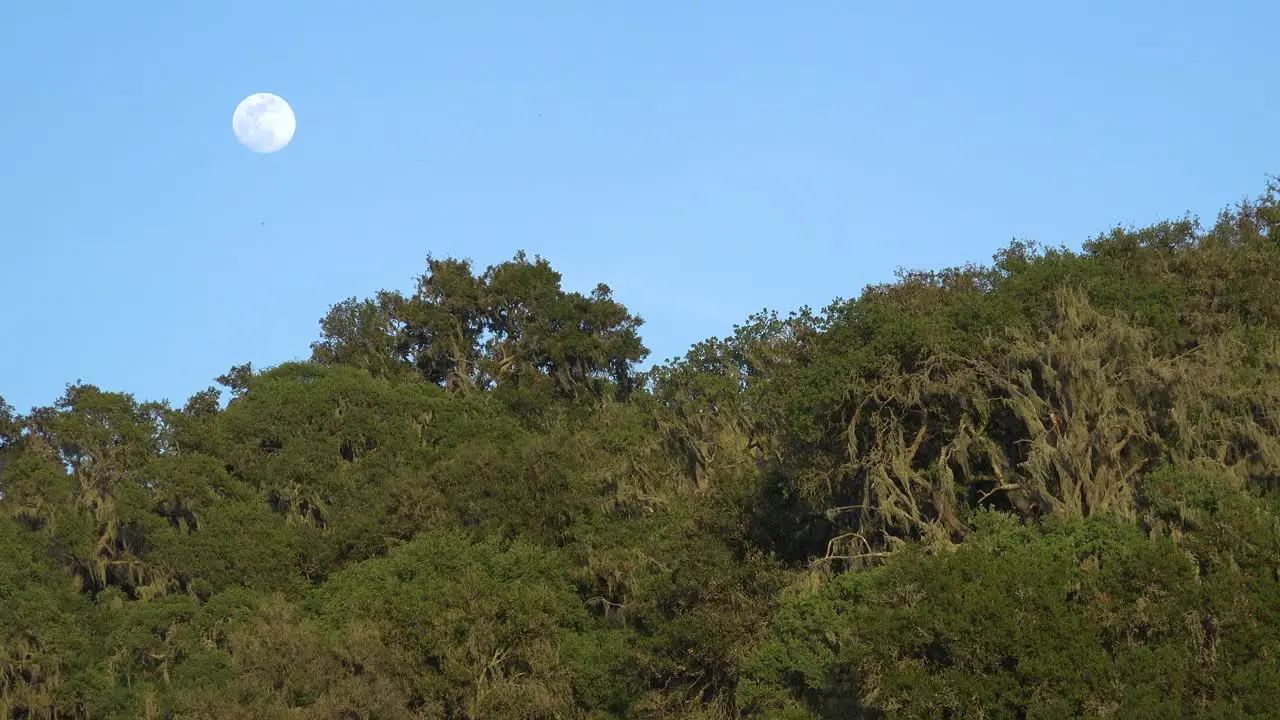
[312,252,649,402]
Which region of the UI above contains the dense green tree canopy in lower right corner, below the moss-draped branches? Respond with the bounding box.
[739,493,1280,717]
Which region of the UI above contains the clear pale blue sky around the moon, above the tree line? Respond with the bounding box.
[0,0,1280,410]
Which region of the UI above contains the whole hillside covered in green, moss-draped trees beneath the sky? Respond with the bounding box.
[0,180,1280,720]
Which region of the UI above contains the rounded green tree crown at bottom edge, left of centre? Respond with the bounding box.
[314,530,588,717]
